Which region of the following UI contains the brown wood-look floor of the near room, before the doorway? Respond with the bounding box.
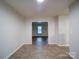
[9,45,72,59]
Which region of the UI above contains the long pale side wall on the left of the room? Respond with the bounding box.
[0,2,24,59]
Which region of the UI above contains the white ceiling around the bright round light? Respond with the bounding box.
[5,0,73,17]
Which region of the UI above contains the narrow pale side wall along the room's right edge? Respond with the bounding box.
[69,1,79,59]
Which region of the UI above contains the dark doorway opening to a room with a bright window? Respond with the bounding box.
[32,22,48,45]
